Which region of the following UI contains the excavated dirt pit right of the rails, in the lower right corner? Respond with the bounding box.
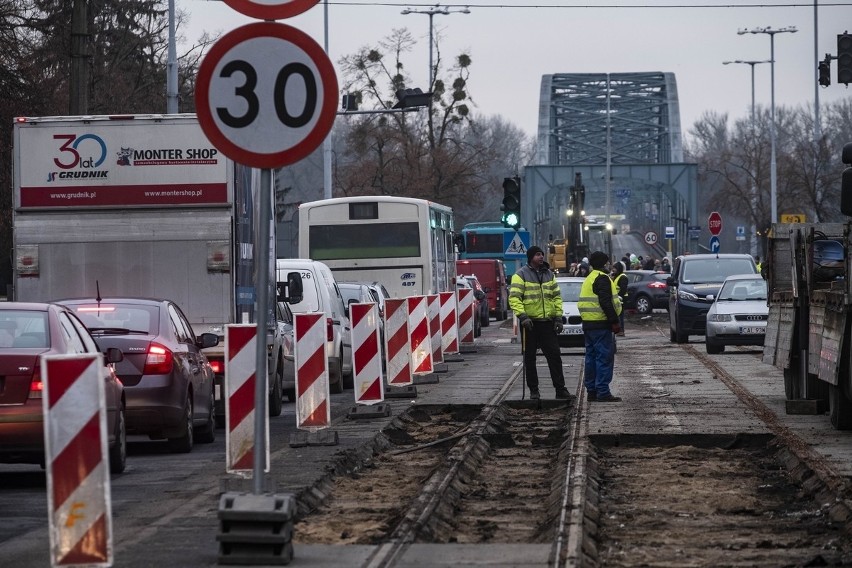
[592,441,852,567]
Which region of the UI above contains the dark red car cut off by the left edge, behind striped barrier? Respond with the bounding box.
[0,302,127,473]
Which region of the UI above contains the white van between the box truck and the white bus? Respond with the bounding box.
[275,258,352,393]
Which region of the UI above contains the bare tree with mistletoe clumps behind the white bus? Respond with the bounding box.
[334,29,528,226]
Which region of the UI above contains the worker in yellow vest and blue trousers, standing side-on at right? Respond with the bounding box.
[577,250,621,402]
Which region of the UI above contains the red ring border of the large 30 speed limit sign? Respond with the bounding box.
[195,22,338,168]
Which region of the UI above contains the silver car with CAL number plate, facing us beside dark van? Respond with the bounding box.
[705,274,769,353]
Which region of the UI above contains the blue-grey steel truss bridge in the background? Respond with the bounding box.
[521,72,697,253]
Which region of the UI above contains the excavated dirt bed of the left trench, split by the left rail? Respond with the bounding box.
[294,405,569,544]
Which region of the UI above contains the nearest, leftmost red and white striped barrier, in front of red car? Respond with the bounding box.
[41,354,113,566]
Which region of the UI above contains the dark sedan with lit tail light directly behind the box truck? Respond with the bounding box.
[61,298,219,453]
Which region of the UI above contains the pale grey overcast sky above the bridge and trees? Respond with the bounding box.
[181,0,852,145]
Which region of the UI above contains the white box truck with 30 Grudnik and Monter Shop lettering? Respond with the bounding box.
[12,114,296,422]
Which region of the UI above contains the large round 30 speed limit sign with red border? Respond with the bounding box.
[195,22,338,168]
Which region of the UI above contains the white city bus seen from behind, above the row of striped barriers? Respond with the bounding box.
[299,196,456,298]
